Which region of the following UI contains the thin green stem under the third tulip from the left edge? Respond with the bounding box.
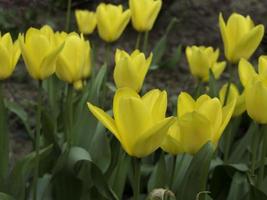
[66,84,73,148]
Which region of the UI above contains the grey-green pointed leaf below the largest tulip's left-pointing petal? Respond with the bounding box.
[90,122,111,172]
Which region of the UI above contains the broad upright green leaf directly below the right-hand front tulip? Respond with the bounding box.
[178,142,214,200]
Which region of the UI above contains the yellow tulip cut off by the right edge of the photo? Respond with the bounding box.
[238,56,267,124]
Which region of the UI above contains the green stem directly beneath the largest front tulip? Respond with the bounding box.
[132,157,141,200]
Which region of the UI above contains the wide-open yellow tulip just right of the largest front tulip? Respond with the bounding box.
[162,92,235,154]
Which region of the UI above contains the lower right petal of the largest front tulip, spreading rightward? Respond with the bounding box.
[134,117,175,157]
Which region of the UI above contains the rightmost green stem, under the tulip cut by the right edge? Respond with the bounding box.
[258,125,267,186]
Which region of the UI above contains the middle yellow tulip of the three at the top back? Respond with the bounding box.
[96,3,131,42]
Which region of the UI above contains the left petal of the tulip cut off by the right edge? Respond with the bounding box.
[238,59,256,87]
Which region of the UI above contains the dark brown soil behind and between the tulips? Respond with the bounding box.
[0,0,267,162]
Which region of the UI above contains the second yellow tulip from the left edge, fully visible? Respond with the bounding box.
[19,25,63,80]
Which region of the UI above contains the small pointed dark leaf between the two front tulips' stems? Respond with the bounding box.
[147,152,167,192]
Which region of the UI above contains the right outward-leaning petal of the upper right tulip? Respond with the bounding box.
[233,25,264,62]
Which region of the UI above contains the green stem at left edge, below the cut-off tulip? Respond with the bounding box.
[0,82,9,191]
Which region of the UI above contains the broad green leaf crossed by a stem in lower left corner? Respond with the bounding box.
[8,145,53,200]
